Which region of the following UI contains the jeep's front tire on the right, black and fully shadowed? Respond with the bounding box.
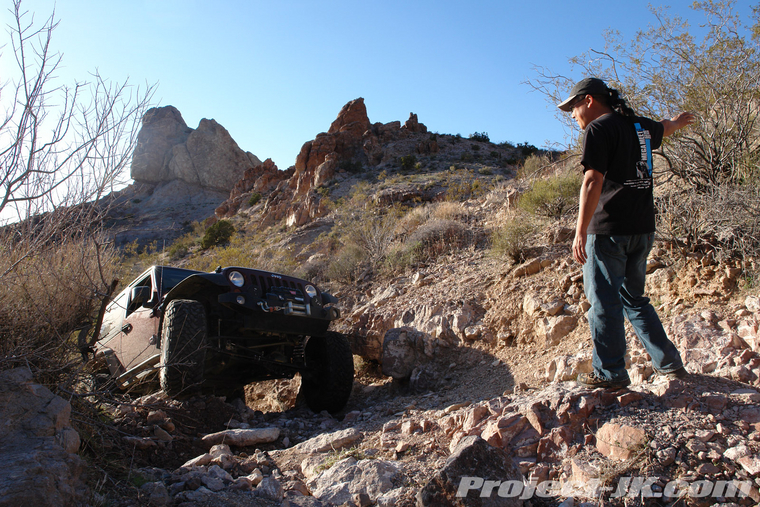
[301,331,354,413]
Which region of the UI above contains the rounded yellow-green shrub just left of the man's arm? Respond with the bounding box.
[517,173,582,218]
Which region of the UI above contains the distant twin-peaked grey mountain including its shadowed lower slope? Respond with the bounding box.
[101,106,268,248]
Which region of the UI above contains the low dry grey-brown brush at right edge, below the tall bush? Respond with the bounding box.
[656,184,760,260]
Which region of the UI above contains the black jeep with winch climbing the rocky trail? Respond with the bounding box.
[95,266,354,412]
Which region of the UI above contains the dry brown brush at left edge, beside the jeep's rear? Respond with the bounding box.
[0,235,117,371]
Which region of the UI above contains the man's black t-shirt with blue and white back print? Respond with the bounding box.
[581,113,664,235]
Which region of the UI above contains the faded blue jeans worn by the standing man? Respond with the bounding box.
[583,233,683,380]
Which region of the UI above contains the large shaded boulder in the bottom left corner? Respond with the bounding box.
[0,368,87,507]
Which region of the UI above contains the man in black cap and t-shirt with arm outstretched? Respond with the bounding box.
[557,78,694,388]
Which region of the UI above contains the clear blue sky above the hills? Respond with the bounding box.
[0,0,749,174]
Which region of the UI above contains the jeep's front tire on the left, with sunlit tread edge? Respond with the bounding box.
[158,299,208,397]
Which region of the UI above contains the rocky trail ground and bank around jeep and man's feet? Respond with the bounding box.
[74,224,760,506]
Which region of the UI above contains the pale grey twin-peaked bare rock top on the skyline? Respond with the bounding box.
[131,106,261,191]
